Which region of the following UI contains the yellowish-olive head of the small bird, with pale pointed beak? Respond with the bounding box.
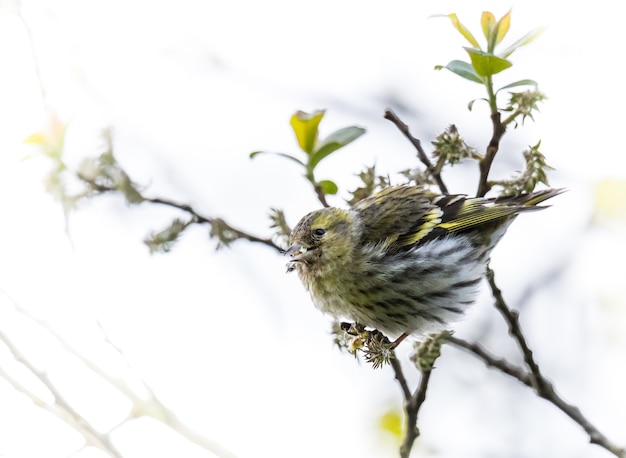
[285,207,355,273]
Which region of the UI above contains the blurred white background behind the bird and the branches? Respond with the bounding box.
[0,0,626,458]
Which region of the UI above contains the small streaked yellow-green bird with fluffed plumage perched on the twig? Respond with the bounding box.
[285,185,563,343]
